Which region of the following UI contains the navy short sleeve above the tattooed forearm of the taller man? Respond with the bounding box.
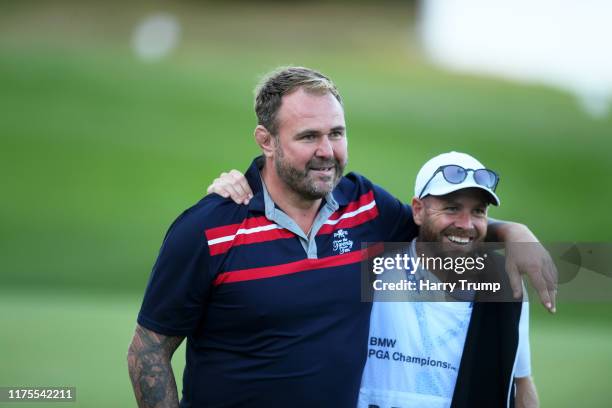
[138,209,211,336]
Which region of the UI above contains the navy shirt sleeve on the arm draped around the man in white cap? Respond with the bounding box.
[374,185,419,242]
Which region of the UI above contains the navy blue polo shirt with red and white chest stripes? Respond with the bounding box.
[138,159,417,408]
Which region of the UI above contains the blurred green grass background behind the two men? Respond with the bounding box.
[0,1,612,407]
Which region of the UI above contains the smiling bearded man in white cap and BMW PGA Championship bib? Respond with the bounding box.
[359,152,538,408]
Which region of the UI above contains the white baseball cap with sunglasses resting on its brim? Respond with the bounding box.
[414,152,500,205]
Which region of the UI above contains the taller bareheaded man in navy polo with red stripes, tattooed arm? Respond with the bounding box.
[128,67,556,407]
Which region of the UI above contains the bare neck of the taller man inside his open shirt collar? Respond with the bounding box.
[261,163,323,235]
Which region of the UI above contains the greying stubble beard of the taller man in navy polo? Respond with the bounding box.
[274,145,346,200]
